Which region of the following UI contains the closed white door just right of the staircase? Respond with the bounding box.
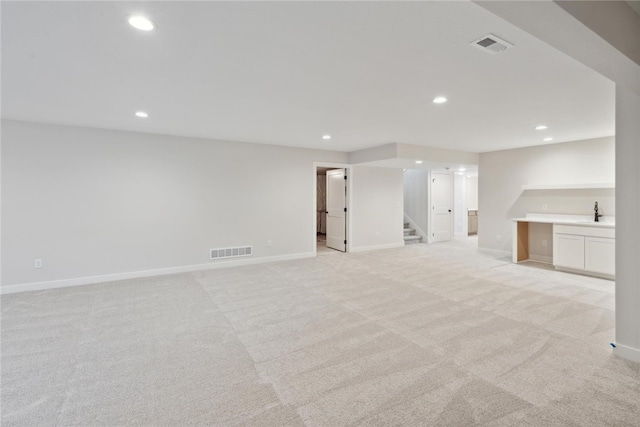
[431,172,453,242]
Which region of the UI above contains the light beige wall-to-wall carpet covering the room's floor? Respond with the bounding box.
[1,239,640,426]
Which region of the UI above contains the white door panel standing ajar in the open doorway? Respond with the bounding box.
[327,169,347,252]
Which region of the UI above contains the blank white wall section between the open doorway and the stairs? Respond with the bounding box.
[349,166,404,251]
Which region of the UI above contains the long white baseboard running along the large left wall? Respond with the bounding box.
[0,252,314,295]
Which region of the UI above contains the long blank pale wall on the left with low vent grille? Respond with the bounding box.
[2,121,350,289]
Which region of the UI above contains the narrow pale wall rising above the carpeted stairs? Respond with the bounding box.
[403,169,429,237]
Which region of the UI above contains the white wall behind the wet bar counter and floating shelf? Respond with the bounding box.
[478,137,615,255]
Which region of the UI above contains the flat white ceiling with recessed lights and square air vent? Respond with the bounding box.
[2,1,614,152]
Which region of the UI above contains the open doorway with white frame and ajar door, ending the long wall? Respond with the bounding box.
[314,165,349,255]
